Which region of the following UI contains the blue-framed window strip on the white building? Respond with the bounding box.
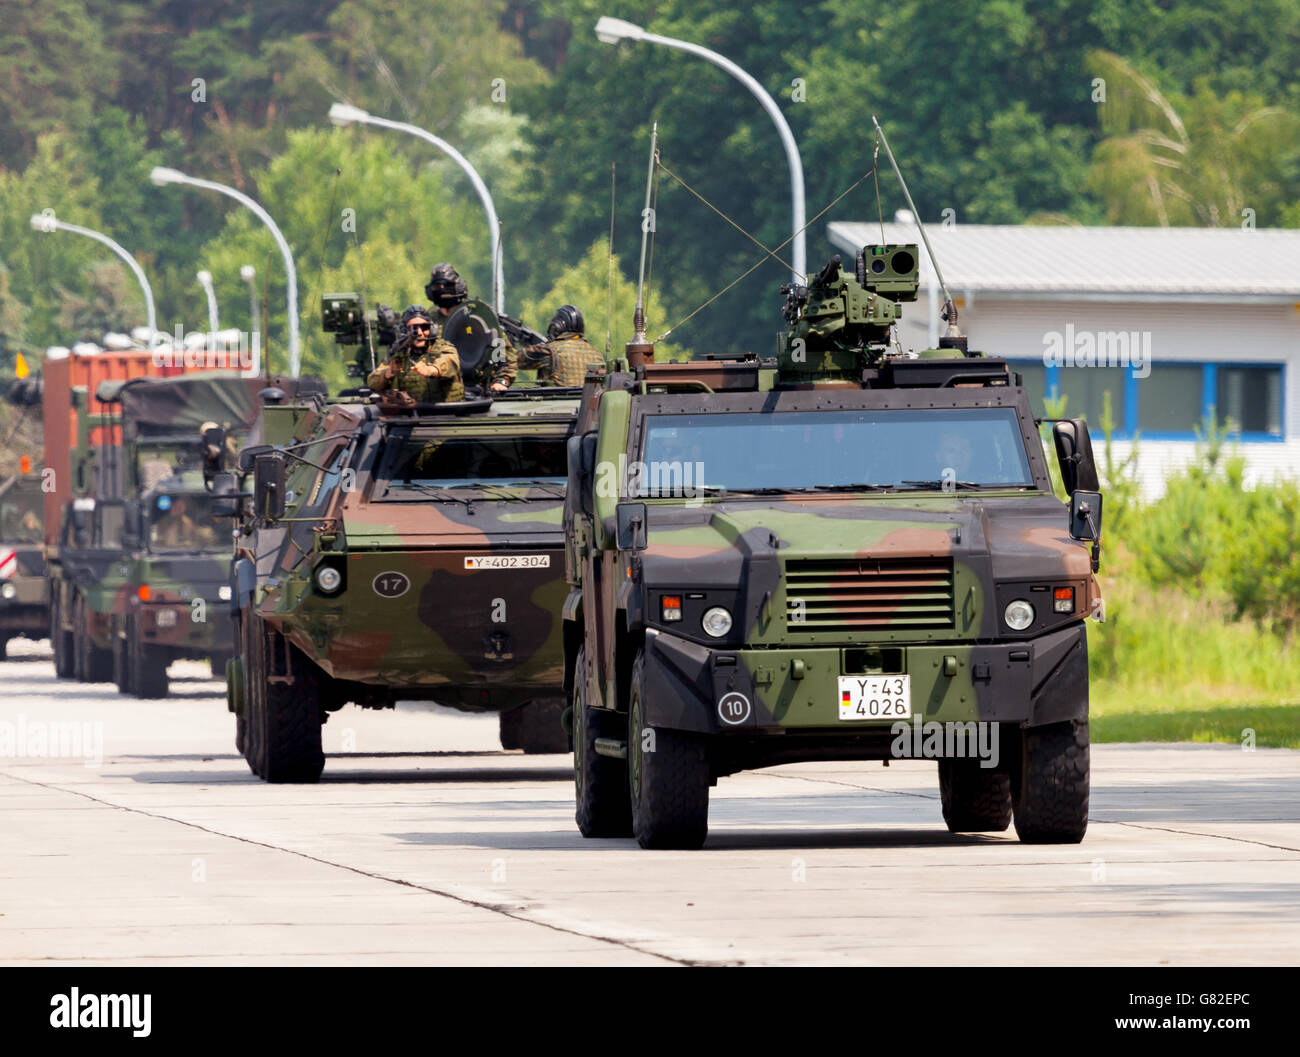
[1008,360,1287,443]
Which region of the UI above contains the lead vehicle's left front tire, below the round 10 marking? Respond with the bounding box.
[628,650,709,849]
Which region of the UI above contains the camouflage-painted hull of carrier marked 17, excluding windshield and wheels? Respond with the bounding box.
[237,395,577,710]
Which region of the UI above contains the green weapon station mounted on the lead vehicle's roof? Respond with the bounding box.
[777,243,919,384]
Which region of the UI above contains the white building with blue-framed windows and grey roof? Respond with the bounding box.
[828,222,1300,494]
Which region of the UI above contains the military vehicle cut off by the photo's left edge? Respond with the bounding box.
[0,473,49,660]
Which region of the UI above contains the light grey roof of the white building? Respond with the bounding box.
[826,221,1300,300]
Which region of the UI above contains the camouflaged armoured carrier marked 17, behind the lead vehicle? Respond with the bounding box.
[228,295,579,781]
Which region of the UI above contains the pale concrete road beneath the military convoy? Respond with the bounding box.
[0,642,1300,965]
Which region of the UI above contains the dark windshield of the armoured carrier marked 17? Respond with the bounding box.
[382,434,567,494]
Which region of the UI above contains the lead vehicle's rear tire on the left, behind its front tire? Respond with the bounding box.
[573,649,632,837]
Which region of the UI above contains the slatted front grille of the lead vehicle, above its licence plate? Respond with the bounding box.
[785,558,954,633]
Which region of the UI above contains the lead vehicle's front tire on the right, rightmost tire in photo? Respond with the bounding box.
[1011,720,1089,844]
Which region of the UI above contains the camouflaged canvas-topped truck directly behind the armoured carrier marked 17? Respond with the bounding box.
[51,371,265,697]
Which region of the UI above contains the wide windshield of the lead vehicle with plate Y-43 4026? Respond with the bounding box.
[638,407,1034,498]
